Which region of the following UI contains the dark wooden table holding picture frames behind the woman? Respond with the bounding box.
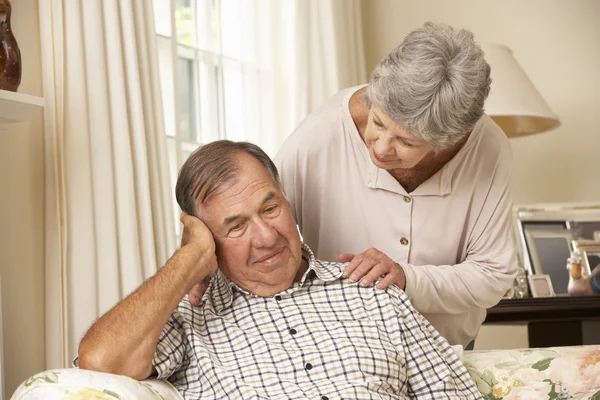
[484,296,600,347]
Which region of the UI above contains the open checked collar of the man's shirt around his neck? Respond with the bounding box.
[202,244,345,313]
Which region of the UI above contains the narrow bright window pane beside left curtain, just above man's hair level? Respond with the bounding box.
[157,36,175,136]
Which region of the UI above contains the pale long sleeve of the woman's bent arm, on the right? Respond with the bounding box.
[400,156,517,314]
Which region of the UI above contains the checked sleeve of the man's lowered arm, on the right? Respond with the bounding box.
[388,286,482,400]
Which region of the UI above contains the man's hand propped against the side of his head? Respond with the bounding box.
[180,213,217,306]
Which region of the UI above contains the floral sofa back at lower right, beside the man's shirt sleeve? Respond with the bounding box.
[463,346,600,400]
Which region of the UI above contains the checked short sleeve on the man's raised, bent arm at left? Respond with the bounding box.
[152,310,185,379]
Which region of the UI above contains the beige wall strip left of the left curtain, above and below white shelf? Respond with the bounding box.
[0,0,44,398]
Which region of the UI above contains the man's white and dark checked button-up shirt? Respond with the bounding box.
[153,246,481,400]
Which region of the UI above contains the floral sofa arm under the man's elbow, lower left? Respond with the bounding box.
[11,368,181,400]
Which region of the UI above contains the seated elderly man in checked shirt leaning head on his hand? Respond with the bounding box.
[79,141,480,399]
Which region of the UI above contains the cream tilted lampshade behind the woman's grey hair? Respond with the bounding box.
[481,43,560,137]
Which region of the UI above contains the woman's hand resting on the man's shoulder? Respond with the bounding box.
[337,248,406,290]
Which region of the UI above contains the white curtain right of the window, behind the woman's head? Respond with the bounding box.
[258,0,368,155]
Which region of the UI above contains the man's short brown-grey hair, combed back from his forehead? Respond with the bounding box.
[175,140,282,216]
